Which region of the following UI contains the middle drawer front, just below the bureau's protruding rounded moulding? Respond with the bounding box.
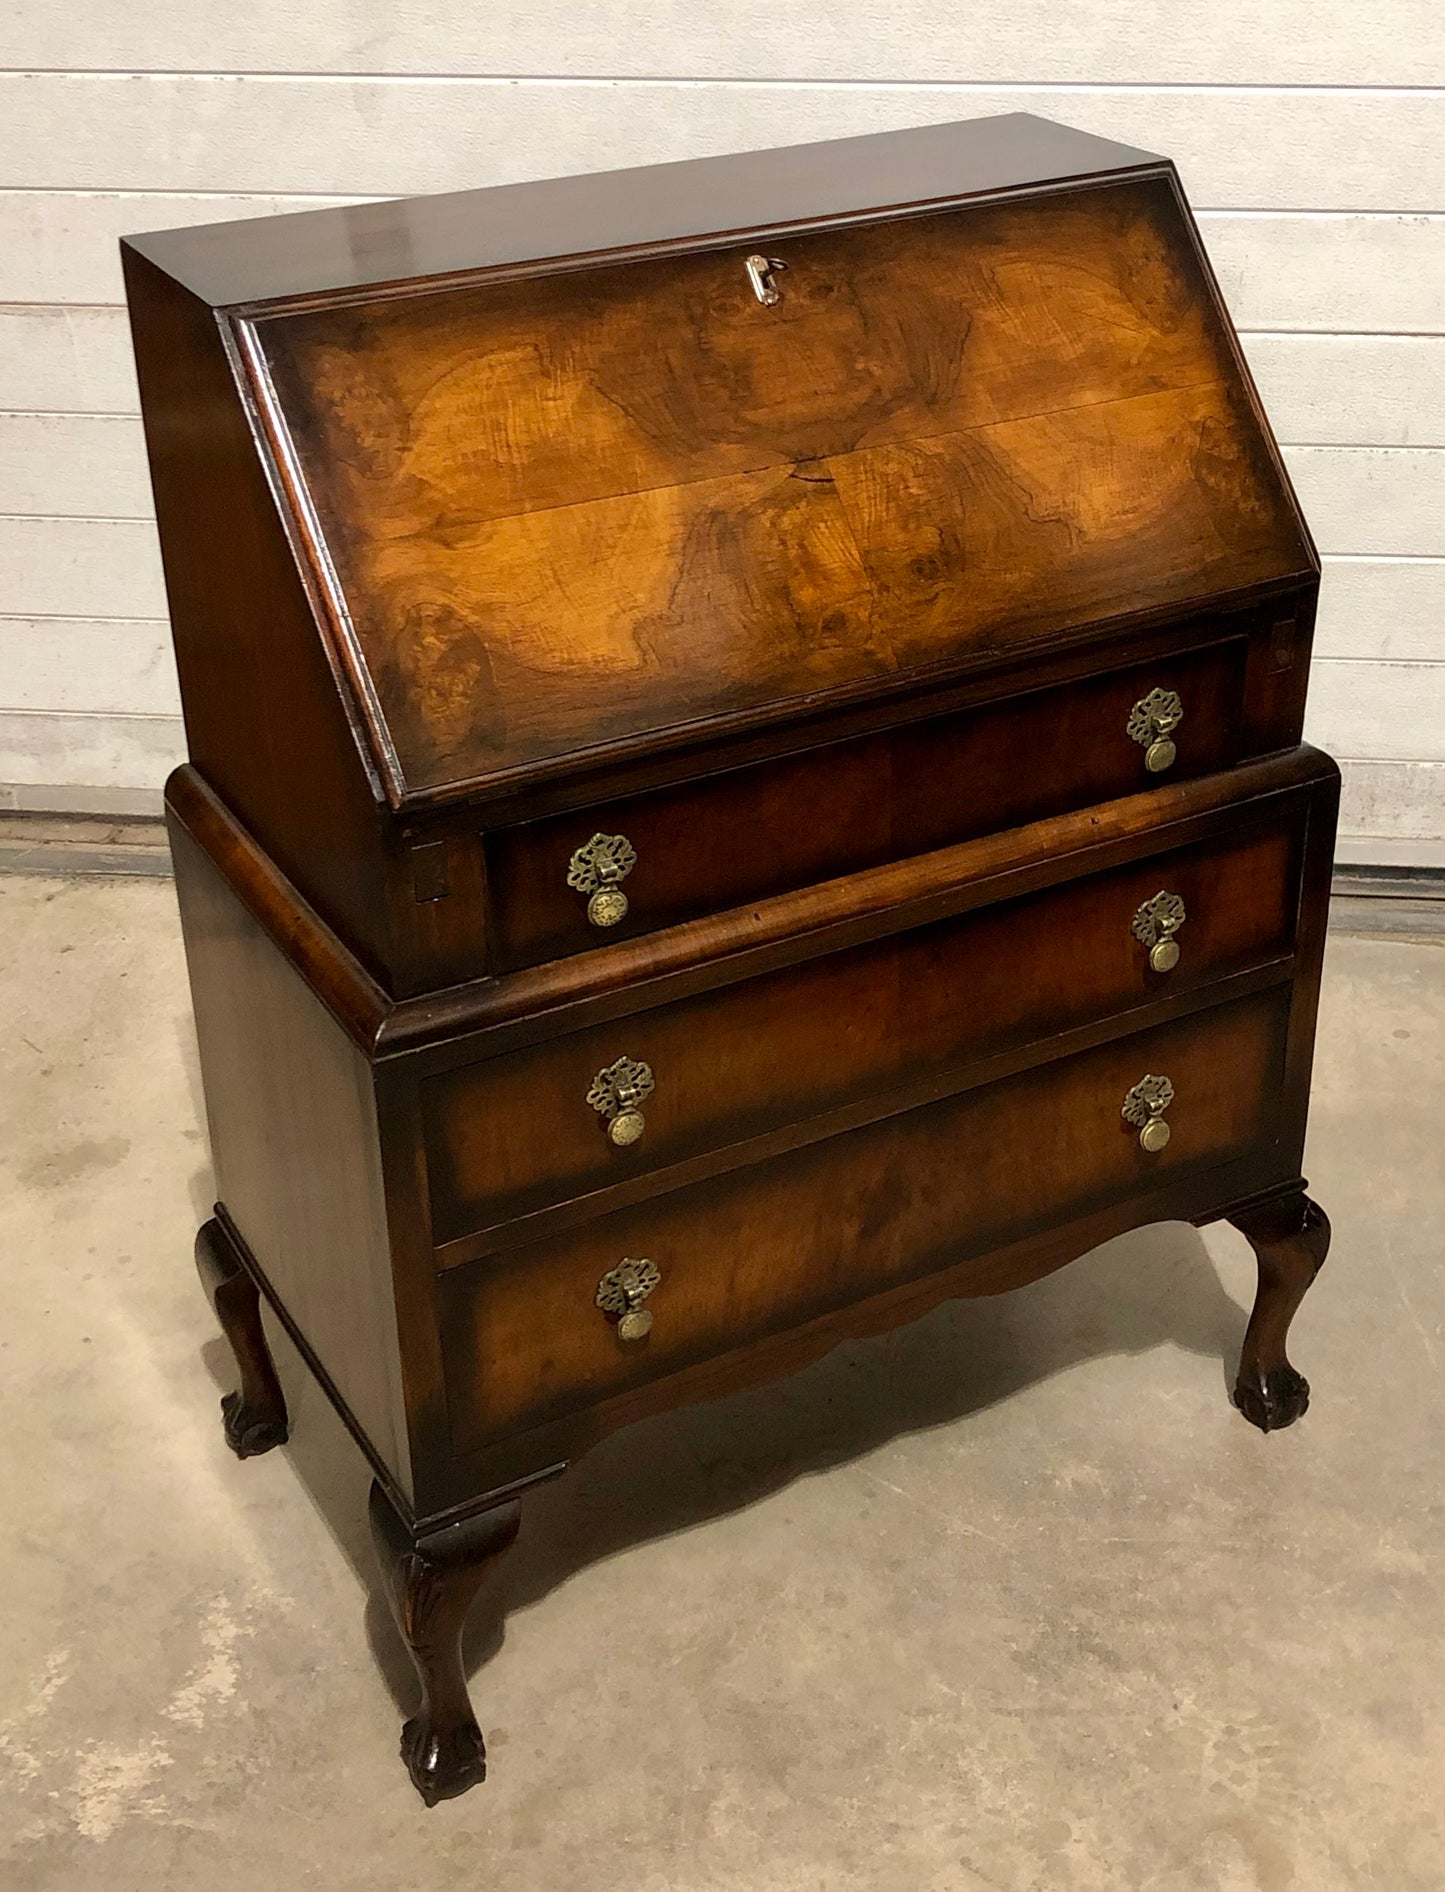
[422,804,1303,1243]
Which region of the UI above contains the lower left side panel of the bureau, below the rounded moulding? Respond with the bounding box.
[170,821,410,1497]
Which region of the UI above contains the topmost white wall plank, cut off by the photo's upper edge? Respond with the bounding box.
[6,0,1445,85]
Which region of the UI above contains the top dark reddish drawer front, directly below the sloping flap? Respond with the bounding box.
[484,636,1248,971]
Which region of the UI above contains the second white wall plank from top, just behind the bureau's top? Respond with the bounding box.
[0,72,1445,212]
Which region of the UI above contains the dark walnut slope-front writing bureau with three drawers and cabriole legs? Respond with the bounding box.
[125,117,1337,1801]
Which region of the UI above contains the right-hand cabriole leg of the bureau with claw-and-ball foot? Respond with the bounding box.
[1229,1190,1330,1432]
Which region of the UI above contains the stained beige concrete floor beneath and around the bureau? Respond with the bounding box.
[0,878,1445,1892]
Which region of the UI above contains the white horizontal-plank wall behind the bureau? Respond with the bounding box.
[0,11,1445,861]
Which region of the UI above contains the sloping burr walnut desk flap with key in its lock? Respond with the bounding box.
[242,170,1313,798]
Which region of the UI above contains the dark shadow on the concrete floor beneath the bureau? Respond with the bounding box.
[206,1222,1245,1714]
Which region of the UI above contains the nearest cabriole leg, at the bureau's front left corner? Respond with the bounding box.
[371,1483,522,1807]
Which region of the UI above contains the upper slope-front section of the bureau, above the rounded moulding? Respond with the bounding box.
[123,117,1318,997]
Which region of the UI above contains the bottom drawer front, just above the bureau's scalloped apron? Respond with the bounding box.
[439,991,1288,1451]
